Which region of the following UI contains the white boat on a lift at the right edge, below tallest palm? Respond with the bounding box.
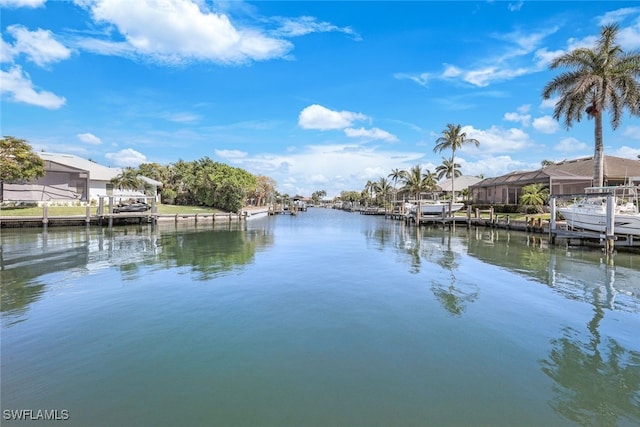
[557,186,640,236]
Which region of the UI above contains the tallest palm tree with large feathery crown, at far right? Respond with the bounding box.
[542,24,640,186]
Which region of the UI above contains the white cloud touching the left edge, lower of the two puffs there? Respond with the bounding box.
[0,65,66,110]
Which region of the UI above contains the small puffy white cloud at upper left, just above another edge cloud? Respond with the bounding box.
[7,25,71,67]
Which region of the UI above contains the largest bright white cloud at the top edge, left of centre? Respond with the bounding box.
[75,0,293,64]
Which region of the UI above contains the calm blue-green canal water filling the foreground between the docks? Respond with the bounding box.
[0,208,640,427]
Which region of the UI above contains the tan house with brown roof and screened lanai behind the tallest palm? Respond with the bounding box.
[469,156,640,204]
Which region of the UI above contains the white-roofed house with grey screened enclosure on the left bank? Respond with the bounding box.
[3,152,162,202]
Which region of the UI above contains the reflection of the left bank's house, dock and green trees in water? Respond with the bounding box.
[0,224,273,317]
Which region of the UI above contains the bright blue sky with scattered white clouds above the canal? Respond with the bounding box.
[0,0,640,196]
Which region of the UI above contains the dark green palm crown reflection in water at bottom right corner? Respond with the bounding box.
[541,288,640,426]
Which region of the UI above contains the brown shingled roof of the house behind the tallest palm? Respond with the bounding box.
[472,156,640,187]
